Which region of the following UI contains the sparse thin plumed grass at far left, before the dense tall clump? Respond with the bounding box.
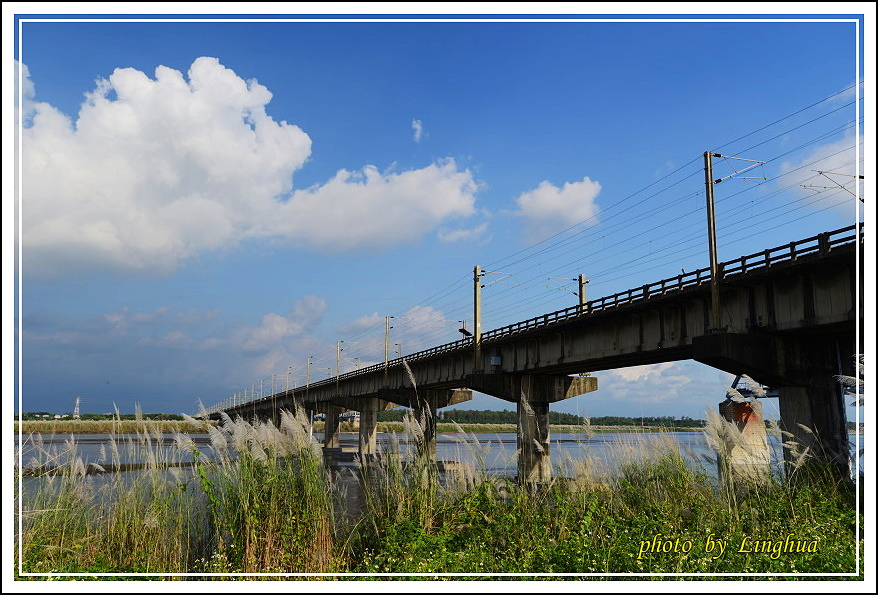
[16,426,210,573]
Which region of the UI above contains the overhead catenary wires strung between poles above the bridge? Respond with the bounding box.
[215,85,861,410]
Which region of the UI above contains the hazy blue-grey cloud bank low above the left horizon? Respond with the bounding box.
[22,295,336,411]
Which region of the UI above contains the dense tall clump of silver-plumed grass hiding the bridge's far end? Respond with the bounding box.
[193,411,335,572]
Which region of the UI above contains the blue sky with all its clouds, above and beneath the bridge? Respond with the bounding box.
[4,7,871,417]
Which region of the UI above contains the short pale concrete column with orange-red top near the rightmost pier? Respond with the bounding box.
[719,399,771,482]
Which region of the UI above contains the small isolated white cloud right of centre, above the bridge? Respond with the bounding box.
[515,176,601,241]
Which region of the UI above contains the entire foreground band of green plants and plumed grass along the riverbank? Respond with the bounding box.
[17,412,863,580]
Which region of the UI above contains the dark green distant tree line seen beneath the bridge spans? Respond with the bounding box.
[378,408,704,428]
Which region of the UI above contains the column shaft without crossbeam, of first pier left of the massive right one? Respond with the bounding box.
[517,376,552,483]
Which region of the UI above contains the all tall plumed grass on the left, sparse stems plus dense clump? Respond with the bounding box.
[16,412,336,574]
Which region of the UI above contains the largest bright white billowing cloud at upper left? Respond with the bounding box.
[21,57,478,276]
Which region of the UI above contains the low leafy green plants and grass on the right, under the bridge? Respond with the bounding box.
[352,412,862,574]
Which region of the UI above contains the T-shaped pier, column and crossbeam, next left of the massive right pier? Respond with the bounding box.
[467,374,598,483]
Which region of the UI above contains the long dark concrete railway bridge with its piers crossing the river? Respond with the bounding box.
[208,224,863,481]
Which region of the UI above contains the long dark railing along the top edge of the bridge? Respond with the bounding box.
[217,223,863,412]
